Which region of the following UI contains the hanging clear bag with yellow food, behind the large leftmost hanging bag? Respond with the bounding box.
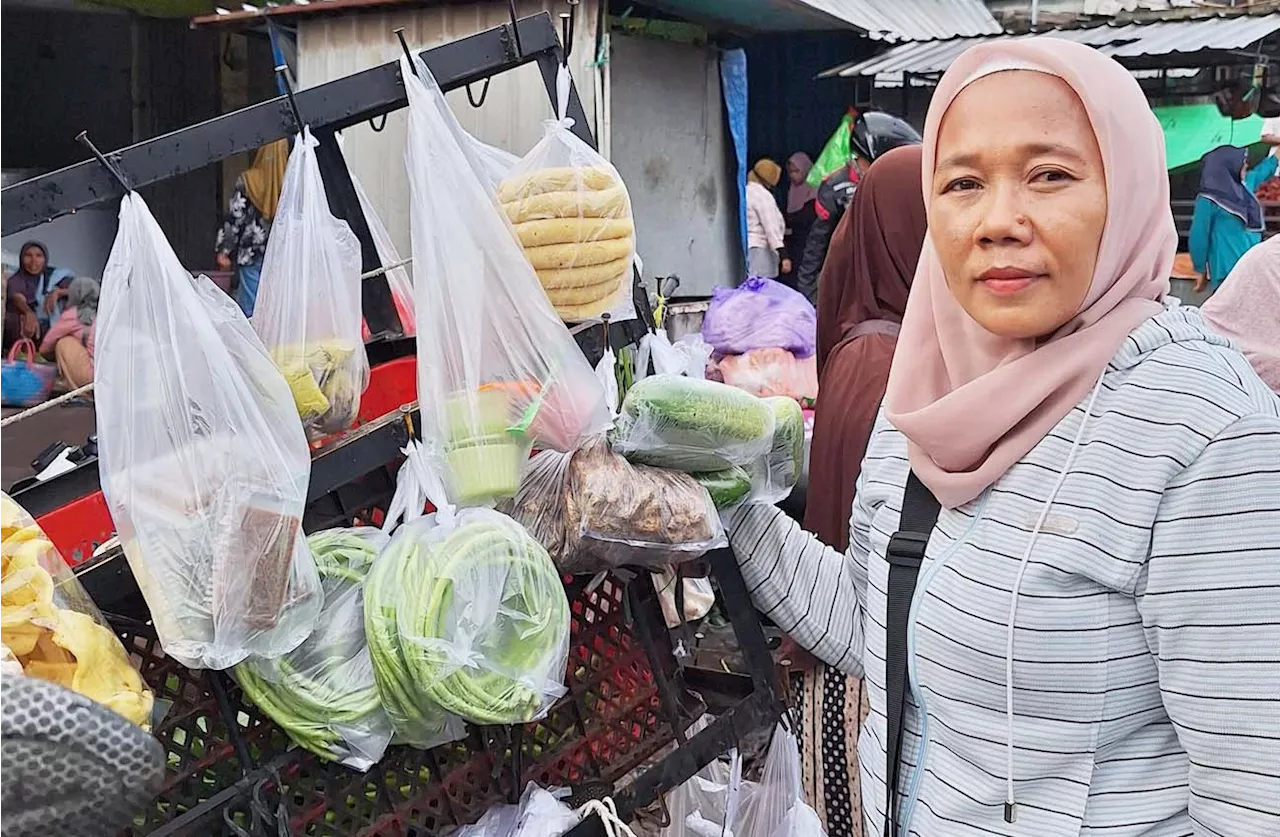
[253,129,369,440]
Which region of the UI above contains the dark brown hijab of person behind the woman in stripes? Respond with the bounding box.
[818,146,927,374]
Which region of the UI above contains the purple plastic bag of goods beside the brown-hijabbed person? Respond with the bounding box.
[703,276,818,357]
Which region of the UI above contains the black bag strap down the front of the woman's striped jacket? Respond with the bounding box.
[884,471,941,837]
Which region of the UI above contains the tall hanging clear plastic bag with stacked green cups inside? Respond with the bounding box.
[402,61,609,504]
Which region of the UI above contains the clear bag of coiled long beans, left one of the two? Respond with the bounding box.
[236,527,392,770]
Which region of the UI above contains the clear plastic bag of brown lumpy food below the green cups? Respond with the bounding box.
[503,438,727,573]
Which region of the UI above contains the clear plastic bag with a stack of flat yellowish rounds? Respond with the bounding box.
[498,67,636,323]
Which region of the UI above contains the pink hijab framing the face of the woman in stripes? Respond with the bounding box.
[884,37,1178,508]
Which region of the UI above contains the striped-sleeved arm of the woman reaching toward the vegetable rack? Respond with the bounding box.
[726,494,867,677]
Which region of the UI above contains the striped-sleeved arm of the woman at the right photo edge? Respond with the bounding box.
[1135,416,1280,837]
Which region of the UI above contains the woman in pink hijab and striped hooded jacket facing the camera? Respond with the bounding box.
[727,38,1280,837]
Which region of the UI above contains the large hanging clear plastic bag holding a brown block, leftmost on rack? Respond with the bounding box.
[95,193,323,669]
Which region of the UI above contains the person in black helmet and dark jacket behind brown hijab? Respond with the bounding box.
[796,110,920,305]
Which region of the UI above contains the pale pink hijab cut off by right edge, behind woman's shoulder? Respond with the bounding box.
[1201,237,1280,392]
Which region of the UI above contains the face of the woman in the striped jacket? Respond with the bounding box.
[929,70,1107,338]
